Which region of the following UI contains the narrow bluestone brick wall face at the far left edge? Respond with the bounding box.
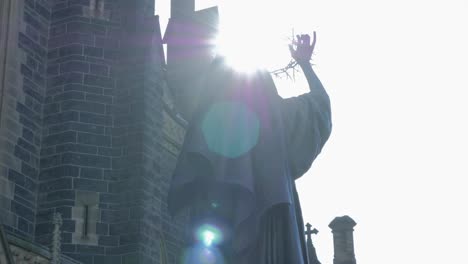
[0,0,51,240]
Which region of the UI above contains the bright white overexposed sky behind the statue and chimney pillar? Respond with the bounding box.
[156,0,468,264]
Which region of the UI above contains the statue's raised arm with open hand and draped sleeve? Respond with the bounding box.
[281,32,331,179]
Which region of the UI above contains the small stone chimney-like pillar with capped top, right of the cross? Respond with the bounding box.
[328,215,356,264]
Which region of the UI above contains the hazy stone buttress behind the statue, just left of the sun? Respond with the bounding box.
[163,6,219,119]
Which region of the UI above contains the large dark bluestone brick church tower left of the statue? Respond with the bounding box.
[0,0,189,264]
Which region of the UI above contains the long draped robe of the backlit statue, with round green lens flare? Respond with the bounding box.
[168,58,331,264]
